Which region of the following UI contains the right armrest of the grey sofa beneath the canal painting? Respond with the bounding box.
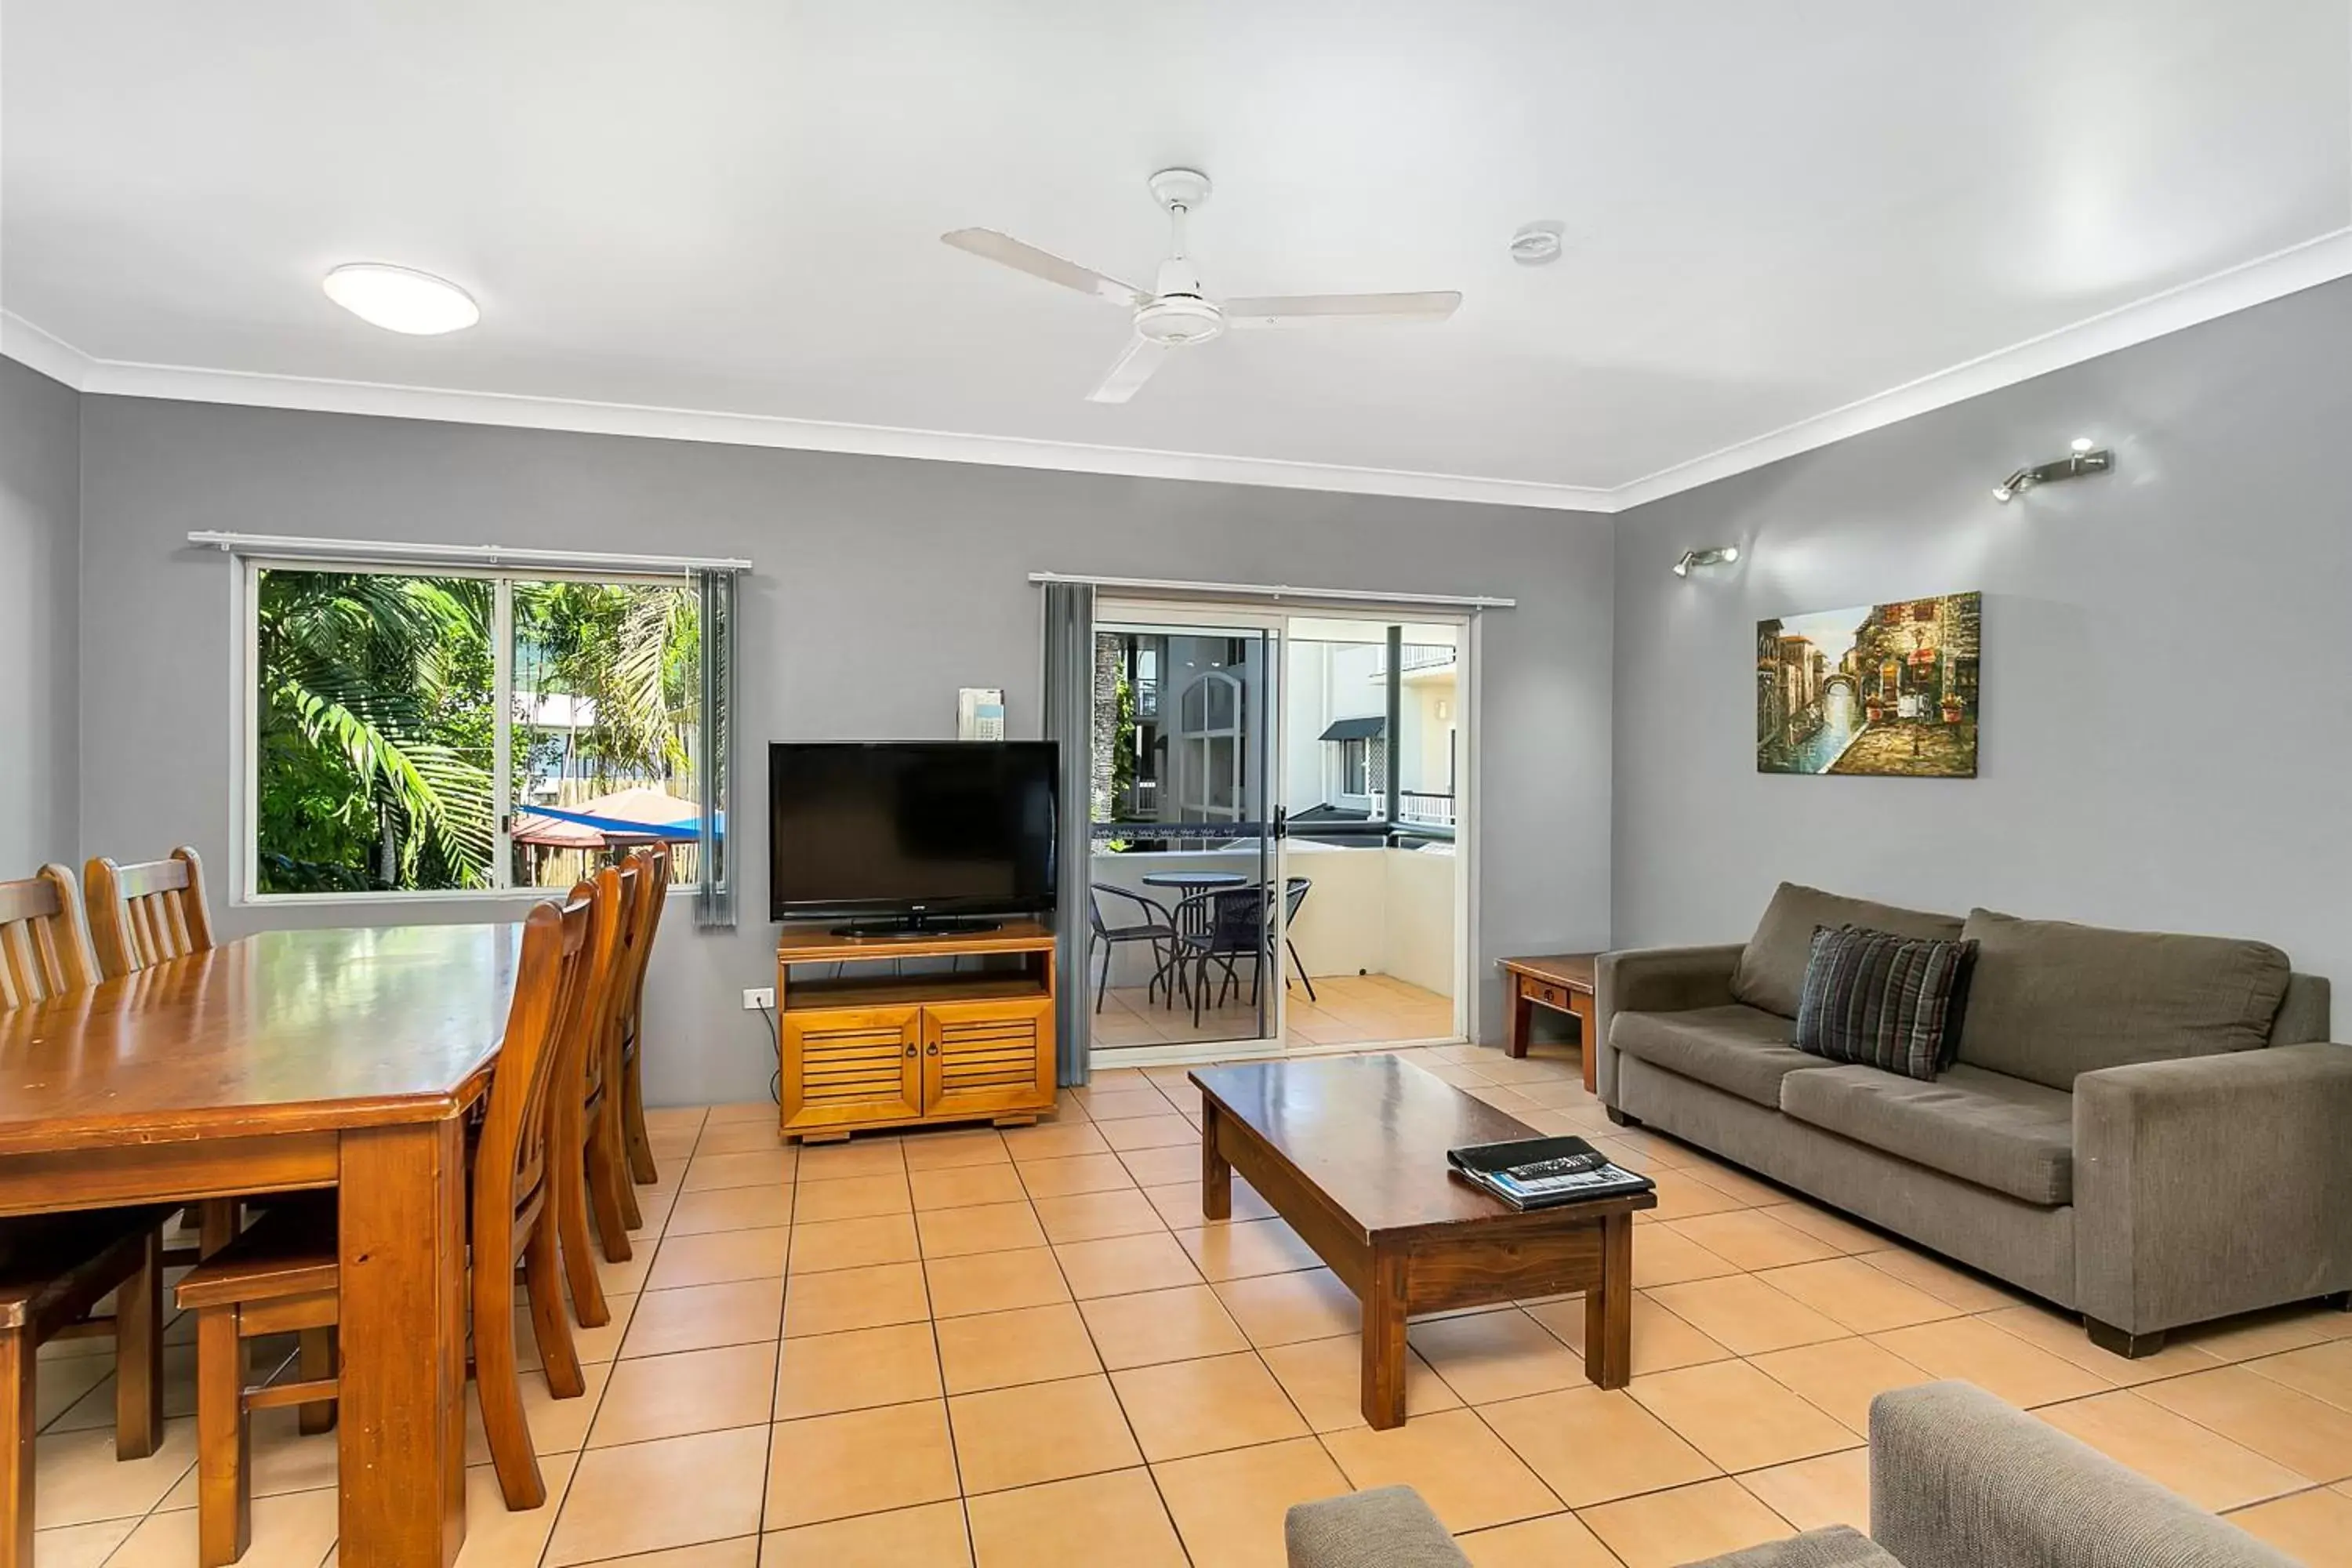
[2074,1044,2352,1333]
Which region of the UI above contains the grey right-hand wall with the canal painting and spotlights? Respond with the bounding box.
[1613,270,2352,982]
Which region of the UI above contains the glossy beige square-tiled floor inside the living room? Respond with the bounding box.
[38,1046,2352,1568]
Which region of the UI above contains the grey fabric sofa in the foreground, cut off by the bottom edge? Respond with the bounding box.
[1284,1382,2296,1568]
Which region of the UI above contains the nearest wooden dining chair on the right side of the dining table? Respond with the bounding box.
[176,891,609,1568]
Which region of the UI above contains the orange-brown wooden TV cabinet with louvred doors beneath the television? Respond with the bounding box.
[776,919,1054,1142]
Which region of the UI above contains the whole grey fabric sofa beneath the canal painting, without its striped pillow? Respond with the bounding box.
[1595,884,2352,1356]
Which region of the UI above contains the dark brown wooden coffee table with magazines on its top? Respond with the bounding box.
[1190,1055,1658,1427]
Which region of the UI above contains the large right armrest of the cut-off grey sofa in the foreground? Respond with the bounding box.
[1870,1382,2293,1568]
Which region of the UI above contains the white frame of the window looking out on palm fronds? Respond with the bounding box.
[243,555,708,909]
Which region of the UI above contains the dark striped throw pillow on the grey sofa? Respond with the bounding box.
[1797,926,1976,1079]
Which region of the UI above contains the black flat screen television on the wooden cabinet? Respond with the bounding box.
[767,741,1061,928]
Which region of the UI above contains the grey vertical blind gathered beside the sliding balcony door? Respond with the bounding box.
[1044,583,1094,1083]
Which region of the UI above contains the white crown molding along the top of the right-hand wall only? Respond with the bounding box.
[1609,228,2352,513]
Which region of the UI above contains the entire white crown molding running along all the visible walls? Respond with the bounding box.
[13,228,2352,513]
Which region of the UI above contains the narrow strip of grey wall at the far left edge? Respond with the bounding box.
[0,360,82,877]
